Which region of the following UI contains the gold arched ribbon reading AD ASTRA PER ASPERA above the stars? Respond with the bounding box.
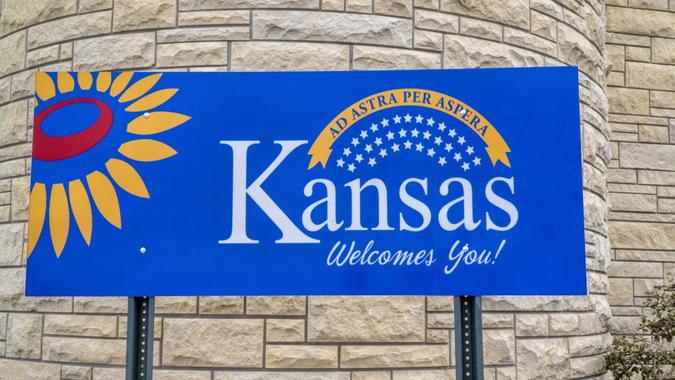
[308,88,511,169]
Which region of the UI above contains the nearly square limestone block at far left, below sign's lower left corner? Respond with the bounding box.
[6,313,42,359]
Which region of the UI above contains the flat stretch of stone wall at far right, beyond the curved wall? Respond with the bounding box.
[607,0,675,335]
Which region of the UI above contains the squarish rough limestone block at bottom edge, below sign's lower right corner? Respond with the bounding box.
[516,338,570,379]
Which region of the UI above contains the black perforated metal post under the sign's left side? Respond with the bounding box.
[126,297,155,380]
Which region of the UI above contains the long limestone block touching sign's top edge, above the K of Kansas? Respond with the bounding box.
[231,41,349,71]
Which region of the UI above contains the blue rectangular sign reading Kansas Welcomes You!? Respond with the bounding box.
[26,67,586,296]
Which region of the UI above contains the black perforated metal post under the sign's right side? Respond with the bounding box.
[455,296,483,380]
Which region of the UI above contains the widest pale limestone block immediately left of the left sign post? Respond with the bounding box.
[42,336,126,365]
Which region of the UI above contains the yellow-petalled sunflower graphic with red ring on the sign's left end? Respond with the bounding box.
[28,72,190,257]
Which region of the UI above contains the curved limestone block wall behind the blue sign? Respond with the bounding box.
[0,0,612,380]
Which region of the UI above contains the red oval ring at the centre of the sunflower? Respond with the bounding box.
[33,98,113,161]
